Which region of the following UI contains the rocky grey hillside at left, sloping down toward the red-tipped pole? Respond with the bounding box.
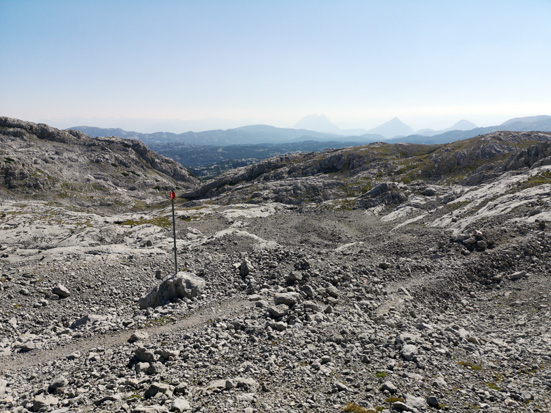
[0,117,199,210]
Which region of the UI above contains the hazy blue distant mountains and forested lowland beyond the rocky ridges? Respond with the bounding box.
[71,115,551,178]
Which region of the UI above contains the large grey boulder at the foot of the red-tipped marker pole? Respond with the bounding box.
[139,271,205,308]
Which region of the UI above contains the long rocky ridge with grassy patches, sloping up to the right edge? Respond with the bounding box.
[184,132,551,208]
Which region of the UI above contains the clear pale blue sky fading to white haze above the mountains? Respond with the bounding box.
[0,0,551,132]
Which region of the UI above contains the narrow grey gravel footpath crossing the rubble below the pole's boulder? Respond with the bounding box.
[0,297,252,372]
